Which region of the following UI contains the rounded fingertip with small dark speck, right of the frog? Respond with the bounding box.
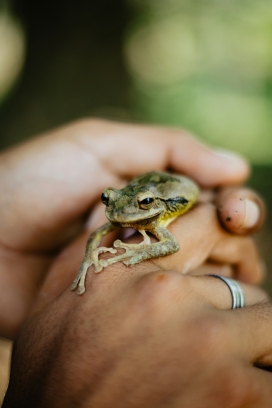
[216,188,265,234]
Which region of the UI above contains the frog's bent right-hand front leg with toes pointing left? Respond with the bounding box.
[101,227,179,266]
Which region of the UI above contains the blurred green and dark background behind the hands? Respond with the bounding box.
[0,0,272,294]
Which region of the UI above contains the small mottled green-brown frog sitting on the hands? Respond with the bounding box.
[71,171,199,295]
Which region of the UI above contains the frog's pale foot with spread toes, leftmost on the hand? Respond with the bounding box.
[71,247,117,295]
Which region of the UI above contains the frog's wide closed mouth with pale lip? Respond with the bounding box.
[106,208,163,226]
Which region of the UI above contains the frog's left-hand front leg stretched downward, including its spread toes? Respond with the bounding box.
[71,222,117,295]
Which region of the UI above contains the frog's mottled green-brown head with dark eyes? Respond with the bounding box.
[101,186,164,228]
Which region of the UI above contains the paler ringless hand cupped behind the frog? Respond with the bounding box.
[0,120,262,338]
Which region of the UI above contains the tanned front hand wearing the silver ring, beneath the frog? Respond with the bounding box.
[3,203,272,408]
